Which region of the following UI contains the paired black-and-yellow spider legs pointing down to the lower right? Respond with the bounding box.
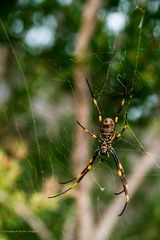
[111,148,129,216]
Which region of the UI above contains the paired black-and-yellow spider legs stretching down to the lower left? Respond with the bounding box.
[48,149,100,198]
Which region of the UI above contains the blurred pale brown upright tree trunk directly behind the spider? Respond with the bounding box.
[71,0,102,240]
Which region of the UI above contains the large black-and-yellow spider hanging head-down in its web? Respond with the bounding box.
[48,79,129,216]
